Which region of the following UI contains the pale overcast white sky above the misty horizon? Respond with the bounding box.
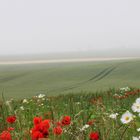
[0,0,140,54]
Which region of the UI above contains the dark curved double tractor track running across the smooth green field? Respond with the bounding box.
[50,66,117,92]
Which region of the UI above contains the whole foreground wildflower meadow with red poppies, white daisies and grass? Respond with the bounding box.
[0,87,140,140]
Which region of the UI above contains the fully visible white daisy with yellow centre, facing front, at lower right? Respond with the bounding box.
[121,111,133,124]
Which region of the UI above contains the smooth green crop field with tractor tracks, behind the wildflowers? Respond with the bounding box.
[0,60,140,98]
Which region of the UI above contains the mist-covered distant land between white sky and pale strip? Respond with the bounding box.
[0,47,140,62]
